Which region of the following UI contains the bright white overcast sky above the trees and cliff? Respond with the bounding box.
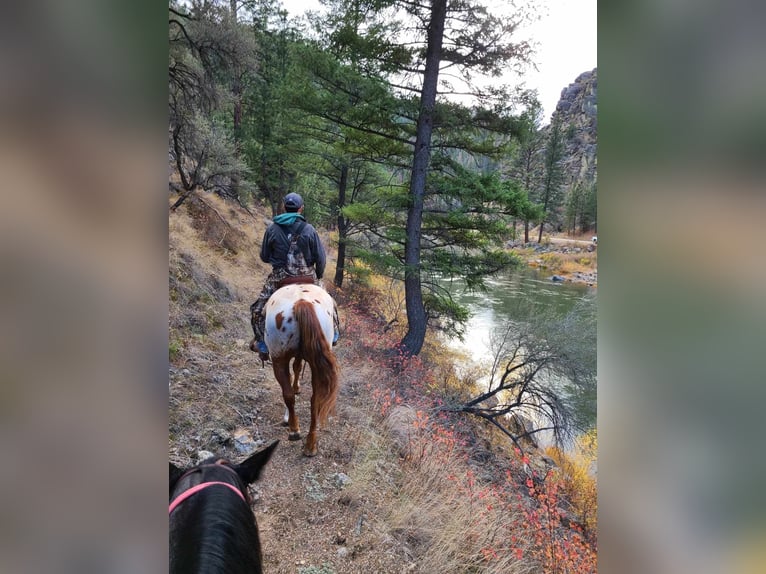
[282,0,597,124]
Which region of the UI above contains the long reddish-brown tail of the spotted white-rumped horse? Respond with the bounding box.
[293,299,338,425]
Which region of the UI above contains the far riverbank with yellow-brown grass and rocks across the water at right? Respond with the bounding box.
[508,236,598,287]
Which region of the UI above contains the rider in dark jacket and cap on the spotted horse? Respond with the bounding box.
[250,193,338,360]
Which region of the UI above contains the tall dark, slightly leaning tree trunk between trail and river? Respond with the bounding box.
[400,0,447,355]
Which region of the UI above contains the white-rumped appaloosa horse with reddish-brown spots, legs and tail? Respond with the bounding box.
[264,284,339,456]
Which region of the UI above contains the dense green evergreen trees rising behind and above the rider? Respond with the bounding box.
[169,0,595,354]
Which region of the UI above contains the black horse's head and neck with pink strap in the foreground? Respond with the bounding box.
[168,440,279,574]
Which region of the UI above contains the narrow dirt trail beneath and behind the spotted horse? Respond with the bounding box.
[252,345,409,574]
